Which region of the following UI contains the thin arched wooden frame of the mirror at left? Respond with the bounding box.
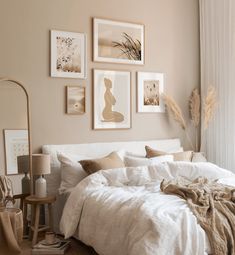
[0,77,33,195]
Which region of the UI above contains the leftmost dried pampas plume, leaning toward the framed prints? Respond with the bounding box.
[162,94,186,130]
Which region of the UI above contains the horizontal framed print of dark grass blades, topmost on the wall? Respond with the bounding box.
[93,18,144,65]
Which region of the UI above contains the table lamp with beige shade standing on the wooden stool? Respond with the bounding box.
[32,154,51,197]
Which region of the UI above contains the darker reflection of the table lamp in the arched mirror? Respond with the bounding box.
[17,155,30,194]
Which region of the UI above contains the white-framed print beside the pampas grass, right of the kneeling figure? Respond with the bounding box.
[137,72,165,112]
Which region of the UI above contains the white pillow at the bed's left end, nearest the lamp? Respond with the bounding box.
[57,152,90,194]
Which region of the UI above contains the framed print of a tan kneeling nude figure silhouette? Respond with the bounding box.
[93,70,131,129]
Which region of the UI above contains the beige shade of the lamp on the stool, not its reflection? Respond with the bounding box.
[32,154,51,175]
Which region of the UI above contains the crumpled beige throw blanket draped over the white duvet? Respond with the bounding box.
[161,177,235,255]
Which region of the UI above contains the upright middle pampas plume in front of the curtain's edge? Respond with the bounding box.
[189,89,201,127]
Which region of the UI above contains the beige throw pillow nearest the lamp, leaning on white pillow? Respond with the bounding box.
[79,152,125,174]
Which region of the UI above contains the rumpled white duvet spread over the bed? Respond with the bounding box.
[60,162,235,255]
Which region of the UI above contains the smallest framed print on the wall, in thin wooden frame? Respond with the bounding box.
[66,86,86,114]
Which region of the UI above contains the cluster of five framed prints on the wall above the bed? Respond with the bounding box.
[51,17,165,130]
